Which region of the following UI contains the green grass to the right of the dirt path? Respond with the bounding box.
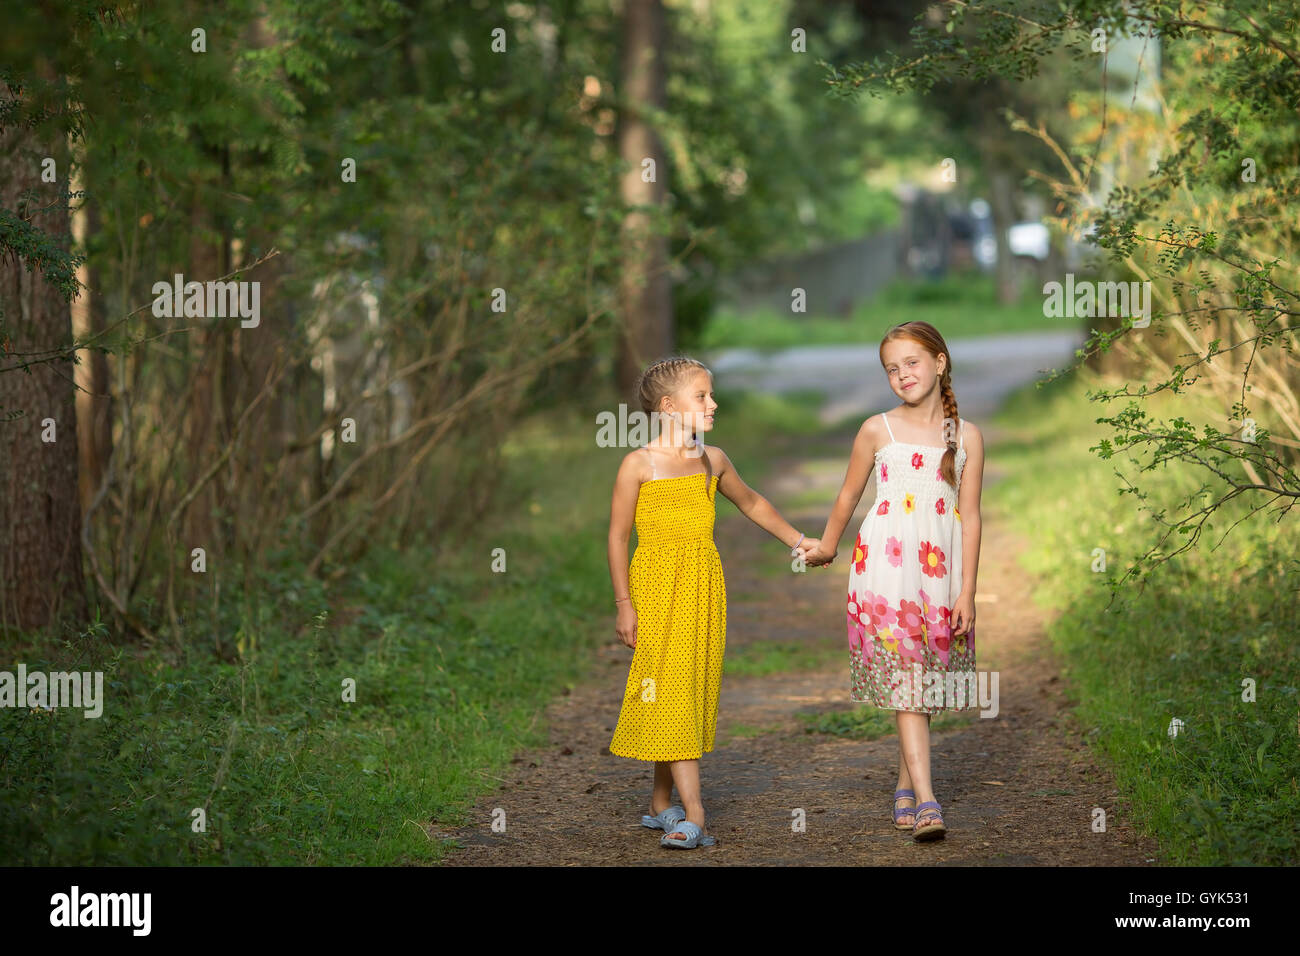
[988,369,1300,865]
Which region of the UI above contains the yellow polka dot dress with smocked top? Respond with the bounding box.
[610,453,727,761]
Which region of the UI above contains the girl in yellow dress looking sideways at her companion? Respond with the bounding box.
[610,356,819,849]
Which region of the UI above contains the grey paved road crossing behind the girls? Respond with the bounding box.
[709,330,1087,425]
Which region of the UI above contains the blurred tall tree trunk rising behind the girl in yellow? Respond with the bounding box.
[618,0,673,394]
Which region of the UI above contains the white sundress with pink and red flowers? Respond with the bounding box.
[848,416,978,714]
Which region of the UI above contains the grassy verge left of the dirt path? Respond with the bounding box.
[0,382,816,865]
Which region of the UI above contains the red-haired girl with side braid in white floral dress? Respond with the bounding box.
[807,321,984,842]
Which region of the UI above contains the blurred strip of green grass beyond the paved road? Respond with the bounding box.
[701,273,1078,350]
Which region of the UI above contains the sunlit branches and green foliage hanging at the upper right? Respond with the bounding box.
[832,0,1300,587]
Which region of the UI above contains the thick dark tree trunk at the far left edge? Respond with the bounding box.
[0,83,86,628]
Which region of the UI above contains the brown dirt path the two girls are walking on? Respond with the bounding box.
[432,429,1157,866]
